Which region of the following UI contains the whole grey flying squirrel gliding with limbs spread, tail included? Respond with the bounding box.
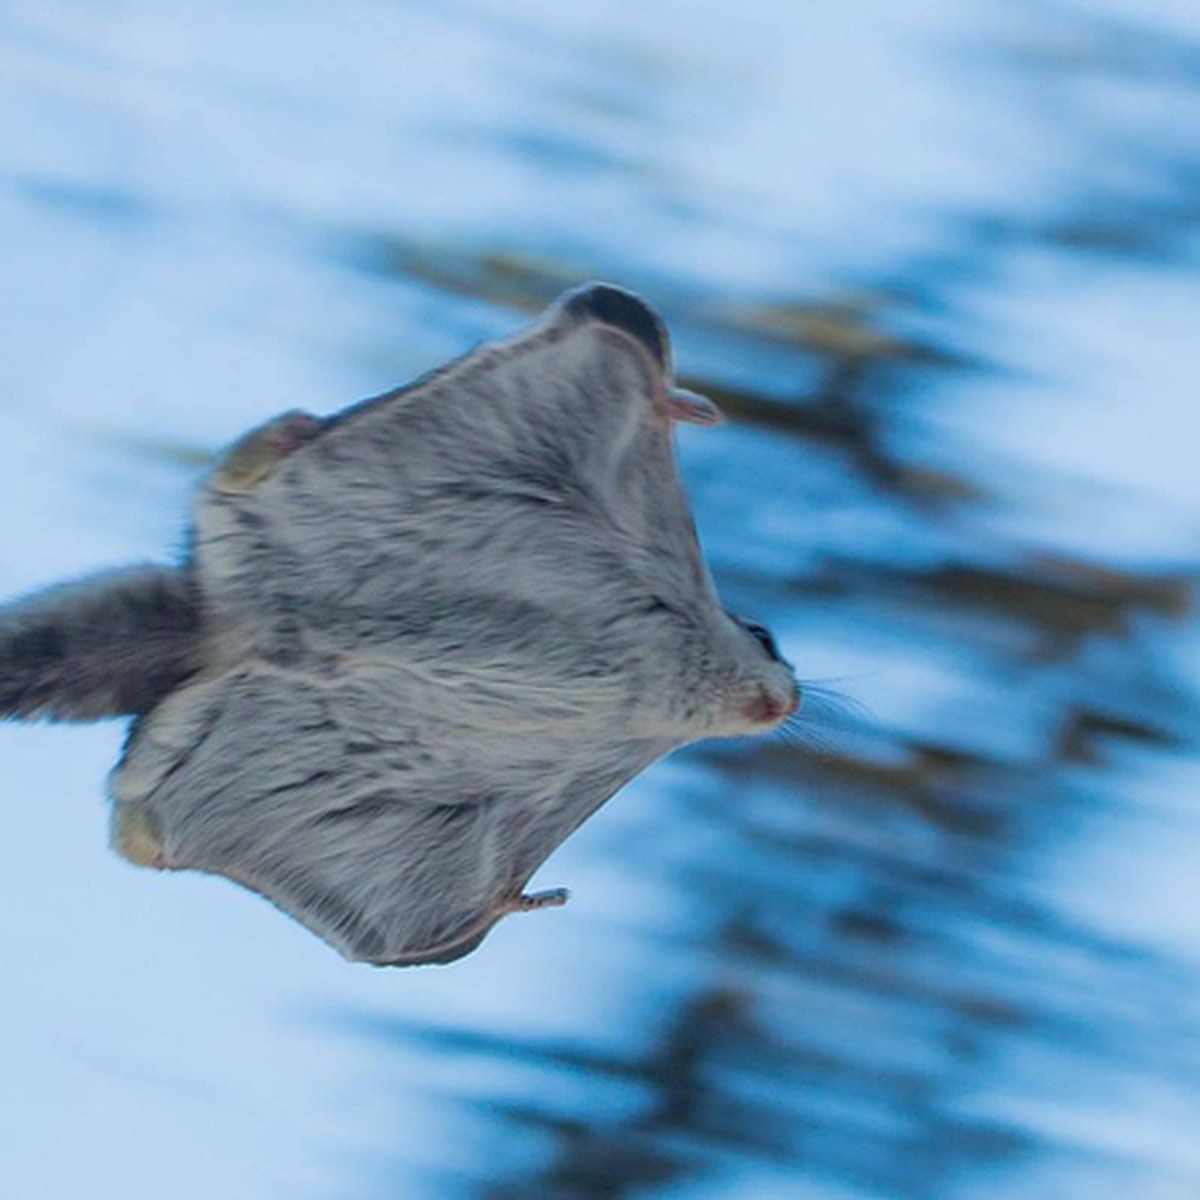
[7,284,798,965]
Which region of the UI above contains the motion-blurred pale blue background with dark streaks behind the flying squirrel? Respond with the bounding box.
[0,0,1200,1200]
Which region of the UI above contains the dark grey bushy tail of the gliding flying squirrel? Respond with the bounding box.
[0,566,200,721]
